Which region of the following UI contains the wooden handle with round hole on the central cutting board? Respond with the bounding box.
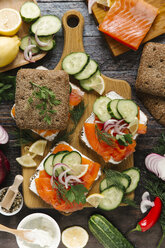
[55,10,84,70]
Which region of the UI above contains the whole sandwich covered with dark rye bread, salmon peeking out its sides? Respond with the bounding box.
[11,67,84,141]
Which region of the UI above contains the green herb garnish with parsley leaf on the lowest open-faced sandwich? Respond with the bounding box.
[53,181,88,204]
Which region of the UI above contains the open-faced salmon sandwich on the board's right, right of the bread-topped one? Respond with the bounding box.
[81,91,147,164]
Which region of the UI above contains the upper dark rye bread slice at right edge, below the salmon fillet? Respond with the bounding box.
[135,42,165,97]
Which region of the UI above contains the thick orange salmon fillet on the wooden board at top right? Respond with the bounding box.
[99,0,158,50]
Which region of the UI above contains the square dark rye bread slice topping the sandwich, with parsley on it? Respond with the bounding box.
[15,69,69,130]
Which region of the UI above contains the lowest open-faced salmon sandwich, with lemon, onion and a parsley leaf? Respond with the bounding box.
[30,142,100,213]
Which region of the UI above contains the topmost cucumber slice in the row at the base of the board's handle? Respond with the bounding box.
[62,52,89,75]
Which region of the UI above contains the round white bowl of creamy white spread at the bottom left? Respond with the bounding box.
[16,213,61,248]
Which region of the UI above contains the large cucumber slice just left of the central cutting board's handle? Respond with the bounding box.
[31,15,61,36]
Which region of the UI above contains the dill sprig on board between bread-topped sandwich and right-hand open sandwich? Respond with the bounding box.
[70,101,86,126]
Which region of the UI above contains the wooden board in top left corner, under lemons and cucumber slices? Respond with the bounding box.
[0,0,46,72]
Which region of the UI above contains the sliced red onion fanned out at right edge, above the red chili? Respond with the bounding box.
[145,153,165,181]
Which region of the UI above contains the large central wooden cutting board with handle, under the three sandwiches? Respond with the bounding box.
[22,10,134,208]
